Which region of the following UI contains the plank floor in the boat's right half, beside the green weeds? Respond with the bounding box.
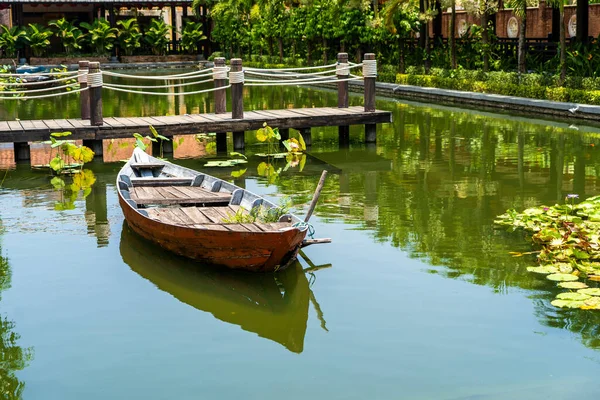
[146,206,292,232]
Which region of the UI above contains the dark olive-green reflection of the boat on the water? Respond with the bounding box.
[120,223,312,353]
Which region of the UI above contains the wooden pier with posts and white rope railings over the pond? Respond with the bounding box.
[0,53,392,159]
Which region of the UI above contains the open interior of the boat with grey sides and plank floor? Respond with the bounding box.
[117,151,304,232]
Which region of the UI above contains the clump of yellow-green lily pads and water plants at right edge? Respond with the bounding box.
[494,194,600,310]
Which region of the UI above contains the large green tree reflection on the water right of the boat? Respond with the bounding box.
[270,108,600,348]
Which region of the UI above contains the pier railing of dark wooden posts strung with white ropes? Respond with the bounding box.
[0,53,377,149]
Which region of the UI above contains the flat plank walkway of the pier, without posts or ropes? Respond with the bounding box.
[0,107,392,143]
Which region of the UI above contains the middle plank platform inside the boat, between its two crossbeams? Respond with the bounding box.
[129,185,231,205]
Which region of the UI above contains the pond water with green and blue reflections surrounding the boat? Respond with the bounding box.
[0,74,600,400]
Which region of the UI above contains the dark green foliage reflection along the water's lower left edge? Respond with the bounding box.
[0,220,32,399]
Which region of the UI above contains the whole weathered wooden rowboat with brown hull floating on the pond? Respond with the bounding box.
[117,148,329,271]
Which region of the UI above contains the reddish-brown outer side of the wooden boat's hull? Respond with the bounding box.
[119,193,306,272]
